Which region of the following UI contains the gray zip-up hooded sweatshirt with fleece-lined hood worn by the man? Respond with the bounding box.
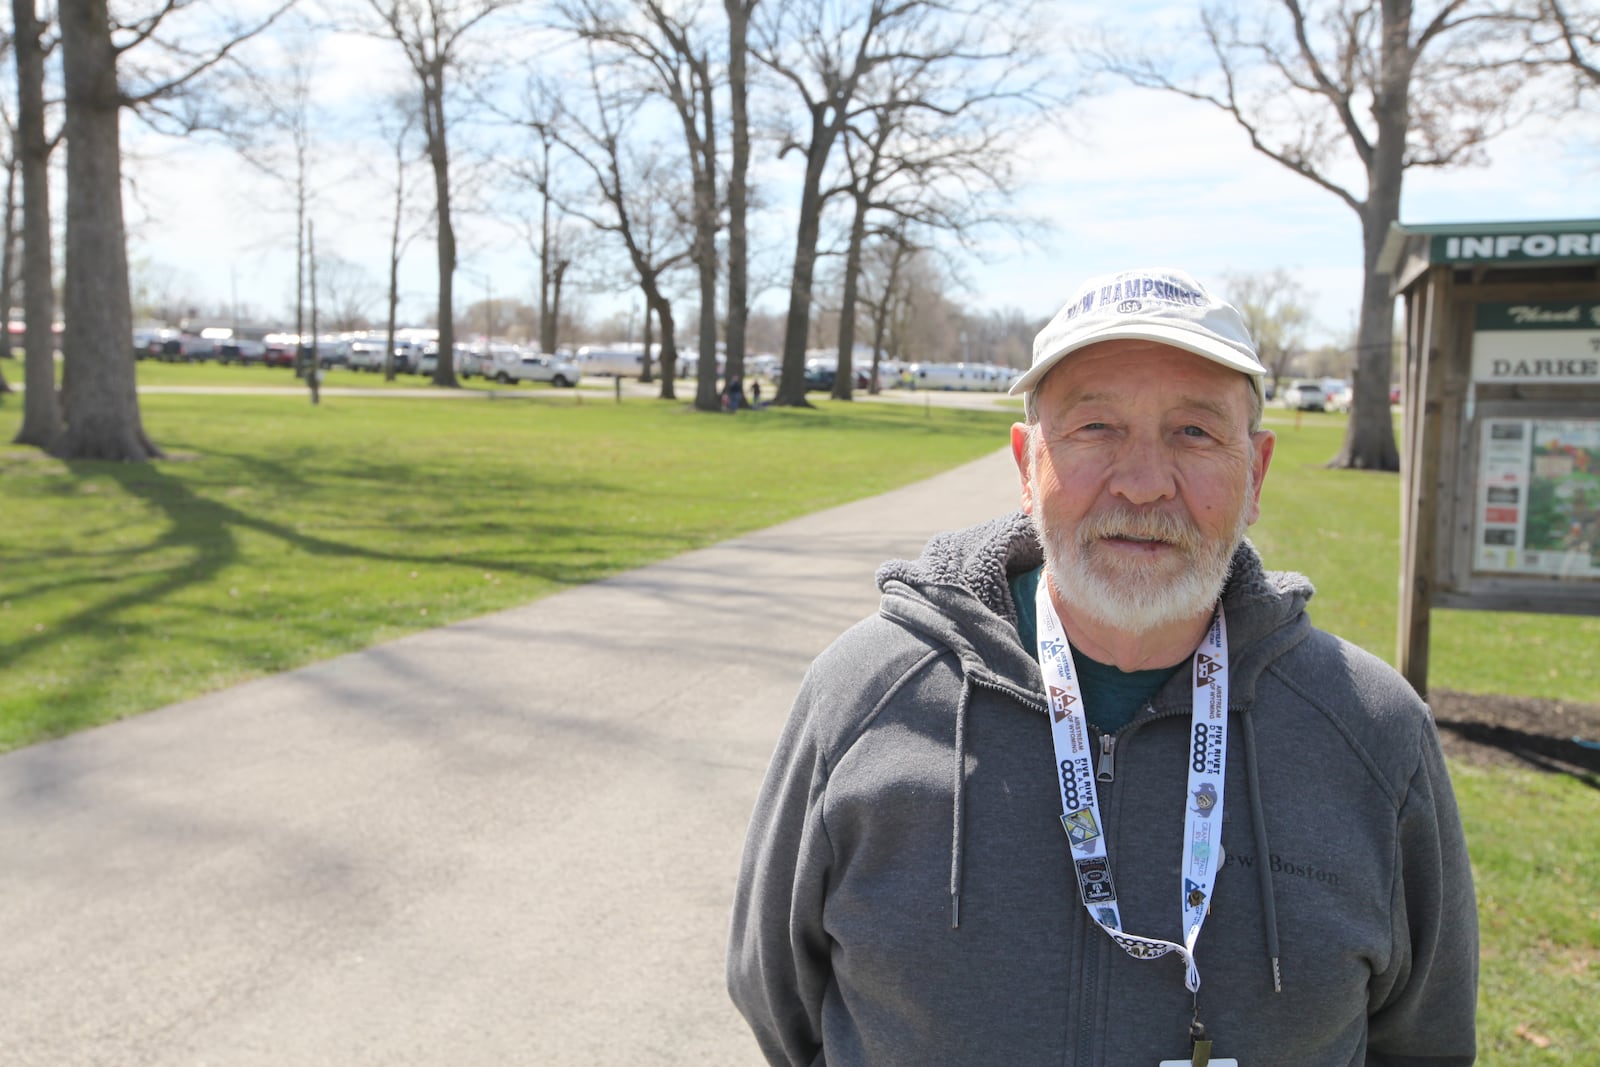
[728,514,1477,1067]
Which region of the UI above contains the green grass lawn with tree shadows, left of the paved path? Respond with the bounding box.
[0,388,1006,749]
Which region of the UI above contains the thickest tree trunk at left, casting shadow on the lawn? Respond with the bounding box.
[51,0,162,462]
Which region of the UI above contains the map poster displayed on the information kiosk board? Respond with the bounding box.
[1474,418,1600,579]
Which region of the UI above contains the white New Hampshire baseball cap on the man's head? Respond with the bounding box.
[1011,267,1267,397]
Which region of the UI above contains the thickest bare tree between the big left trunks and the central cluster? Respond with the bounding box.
[366,0,522,387]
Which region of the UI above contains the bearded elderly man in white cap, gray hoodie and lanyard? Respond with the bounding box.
[728,270,1477,1067]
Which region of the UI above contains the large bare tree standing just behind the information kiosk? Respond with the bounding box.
[1099,0,1528,470]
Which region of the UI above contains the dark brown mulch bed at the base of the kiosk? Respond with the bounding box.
[1427,689,1600,784]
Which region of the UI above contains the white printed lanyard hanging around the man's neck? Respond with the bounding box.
[1035,577,1227,993]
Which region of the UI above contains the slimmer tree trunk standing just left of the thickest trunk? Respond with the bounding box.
[6,0,60,448]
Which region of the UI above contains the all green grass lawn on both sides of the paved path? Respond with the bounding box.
[0,388,1600,1067]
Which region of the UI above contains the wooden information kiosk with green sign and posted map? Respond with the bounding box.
[1379,219,1600,696]
